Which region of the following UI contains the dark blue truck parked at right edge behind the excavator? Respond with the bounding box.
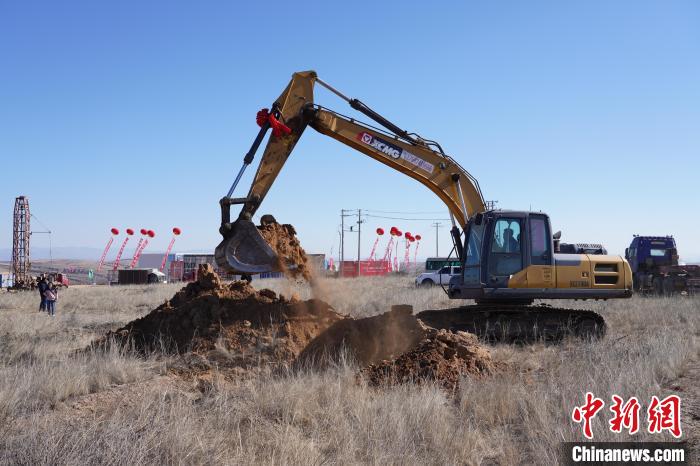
[625,235,700,296]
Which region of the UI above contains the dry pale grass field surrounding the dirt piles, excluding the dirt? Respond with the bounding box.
[0,278,700,465]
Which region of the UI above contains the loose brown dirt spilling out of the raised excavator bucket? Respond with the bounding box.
[257,222,311,281]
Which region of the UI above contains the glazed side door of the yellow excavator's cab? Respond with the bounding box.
[485,217,525,288]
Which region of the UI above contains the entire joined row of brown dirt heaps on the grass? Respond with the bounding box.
[93,264,491,389]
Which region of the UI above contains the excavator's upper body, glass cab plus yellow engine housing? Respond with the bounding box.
[448,210,631,304]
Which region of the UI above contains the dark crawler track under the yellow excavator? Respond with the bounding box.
[416,304,607,343]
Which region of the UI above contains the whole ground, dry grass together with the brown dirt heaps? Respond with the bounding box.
[0,274,700,464]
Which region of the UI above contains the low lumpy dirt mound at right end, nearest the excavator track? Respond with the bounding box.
[361,330,492,390]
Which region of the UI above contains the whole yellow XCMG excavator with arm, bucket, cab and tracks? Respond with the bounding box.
[215,71,632,340]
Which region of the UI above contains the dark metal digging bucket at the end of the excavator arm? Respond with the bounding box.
[214,218,280,274]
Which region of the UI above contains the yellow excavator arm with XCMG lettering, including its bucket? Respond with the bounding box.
[216,71,485,274]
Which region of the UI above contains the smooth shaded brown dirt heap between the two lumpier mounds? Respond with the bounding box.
[297,306,427,366]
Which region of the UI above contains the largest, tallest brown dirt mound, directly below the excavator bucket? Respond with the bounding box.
[102,264,342,367]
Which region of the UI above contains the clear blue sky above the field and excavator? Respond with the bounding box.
[0,0,700,261]
